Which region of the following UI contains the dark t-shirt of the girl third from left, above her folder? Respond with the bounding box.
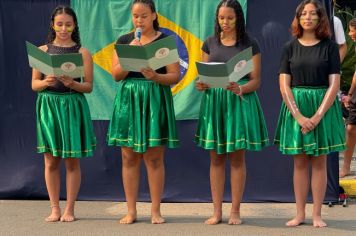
[202,36,260,62]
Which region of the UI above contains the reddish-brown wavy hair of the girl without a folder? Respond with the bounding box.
[291,0,331,39]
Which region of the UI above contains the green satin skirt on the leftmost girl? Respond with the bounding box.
[36,91,96,158]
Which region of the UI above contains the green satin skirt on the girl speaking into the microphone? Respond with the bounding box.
[107,78,179,153]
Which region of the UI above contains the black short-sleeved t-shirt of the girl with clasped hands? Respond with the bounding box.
[279,38,340,87]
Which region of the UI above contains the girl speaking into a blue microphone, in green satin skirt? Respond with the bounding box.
[108,0,179,224]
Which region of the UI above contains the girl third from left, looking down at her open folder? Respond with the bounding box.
[195,0,268,225]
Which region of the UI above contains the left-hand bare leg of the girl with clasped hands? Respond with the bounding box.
[286,154,310,226]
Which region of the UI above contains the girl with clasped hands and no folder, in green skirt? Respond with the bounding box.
[274,0,345,227]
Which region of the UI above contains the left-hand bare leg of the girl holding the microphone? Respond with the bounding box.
[119,147,142,224]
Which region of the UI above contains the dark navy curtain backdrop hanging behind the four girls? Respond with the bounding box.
[0,0,338,202]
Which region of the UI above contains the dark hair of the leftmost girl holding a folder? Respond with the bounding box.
[47,5,81,45]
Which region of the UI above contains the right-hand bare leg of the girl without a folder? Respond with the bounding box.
[311,155,327,227]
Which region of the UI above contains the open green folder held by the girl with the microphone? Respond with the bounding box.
[115,36,179,72]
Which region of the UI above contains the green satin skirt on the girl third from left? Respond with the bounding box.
[195,79,269,154]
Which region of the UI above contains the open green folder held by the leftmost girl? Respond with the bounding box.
[26,41,84,78]
